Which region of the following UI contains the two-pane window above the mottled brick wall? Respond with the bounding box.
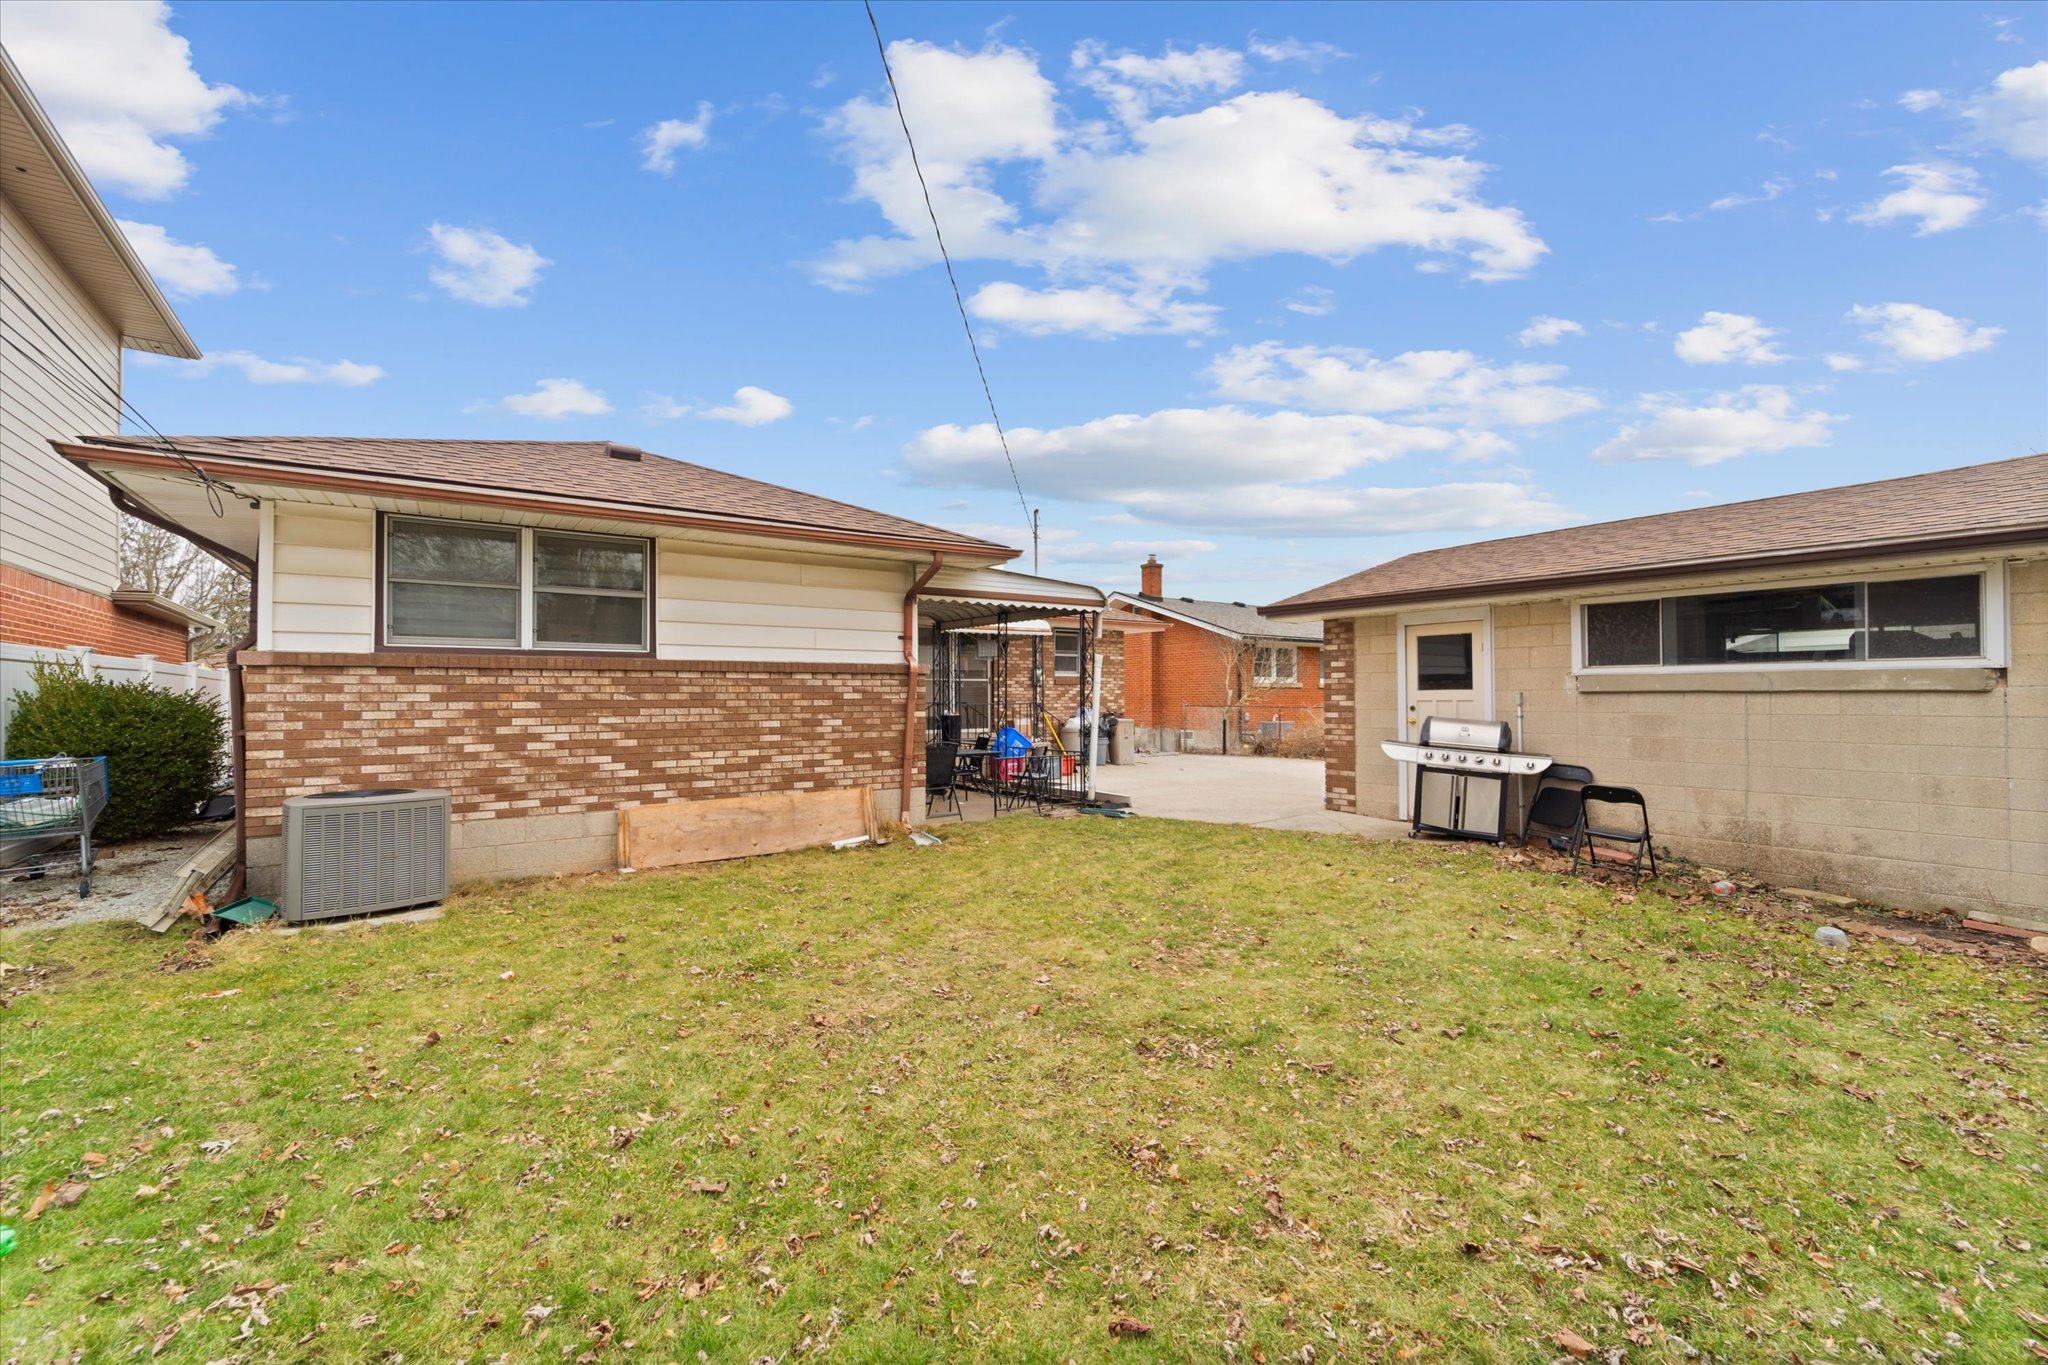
[381,516,653,653]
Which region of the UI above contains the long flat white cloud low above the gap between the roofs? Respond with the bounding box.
[903,405,1567,548]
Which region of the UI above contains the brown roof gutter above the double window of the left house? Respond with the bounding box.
[49,440,1022,561]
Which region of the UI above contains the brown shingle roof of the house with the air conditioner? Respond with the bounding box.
[86,436,1018,559]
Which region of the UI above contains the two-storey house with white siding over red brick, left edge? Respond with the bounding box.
[0,51,205,663]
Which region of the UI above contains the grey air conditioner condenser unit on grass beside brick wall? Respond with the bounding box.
[279,788,451,923]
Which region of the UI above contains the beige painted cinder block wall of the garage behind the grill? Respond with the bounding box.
[1331,563,2048,929]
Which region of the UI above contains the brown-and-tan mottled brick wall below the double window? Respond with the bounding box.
[244,653,924,837]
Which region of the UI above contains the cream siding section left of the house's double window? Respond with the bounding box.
[258,503,377,655]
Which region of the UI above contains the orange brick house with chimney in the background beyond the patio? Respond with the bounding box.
[1110,557,1325,753]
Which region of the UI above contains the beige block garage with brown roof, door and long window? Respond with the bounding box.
[1266,454,2048,929]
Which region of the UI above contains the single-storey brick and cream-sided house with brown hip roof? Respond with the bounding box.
[57,436,1104,892]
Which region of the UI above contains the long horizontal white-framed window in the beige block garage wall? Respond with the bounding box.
[1571,565,2005,673]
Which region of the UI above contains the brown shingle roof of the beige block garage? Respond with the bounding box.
[1266,454,2048,616]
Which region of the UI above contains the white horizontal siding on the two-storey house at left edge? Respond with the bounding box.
[0,199,121,593]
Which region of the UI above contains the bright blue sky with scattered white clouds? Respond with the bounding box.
[0,0,2048,600]
